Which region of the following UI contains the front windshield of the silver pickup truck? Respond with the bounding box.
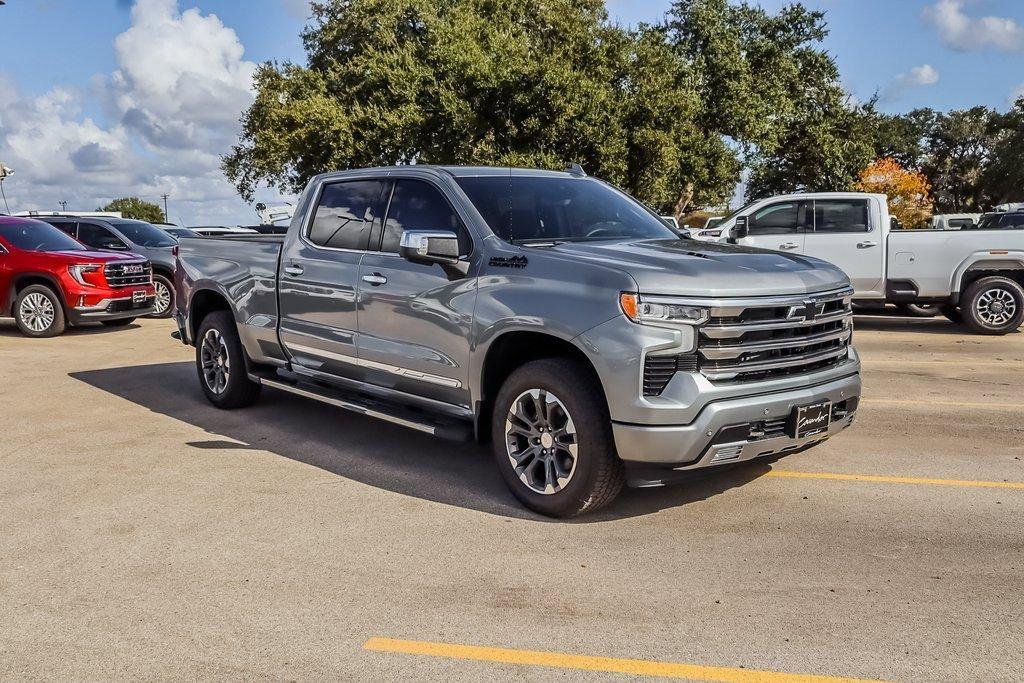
[456,175,679,243]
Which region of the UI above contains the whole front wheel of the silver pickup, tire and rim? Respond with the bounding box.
[492,358,626,517]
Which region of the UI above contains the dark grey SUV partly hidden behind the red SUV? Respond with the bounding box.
[39,215,177,317]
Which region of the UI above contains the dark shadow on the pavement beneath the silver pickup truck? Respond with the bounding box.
[70,362,770,523]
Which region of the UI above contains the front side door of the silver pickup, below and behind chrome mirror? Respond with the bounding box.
[358,178,476,407]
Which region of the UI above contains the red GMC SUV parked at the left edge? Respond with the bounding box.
[0,216,156,337]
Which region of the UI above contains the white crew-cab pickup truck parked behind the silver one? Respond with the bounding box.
[706,193,1024,335]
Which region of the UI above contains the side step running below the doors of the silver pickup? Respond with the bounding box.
[250,374,473,441]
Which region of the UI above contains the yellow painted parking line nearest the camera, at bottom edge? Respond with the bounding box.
[362,638,888,683]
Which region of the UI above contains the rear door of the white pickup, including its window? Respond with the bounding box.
[804,199,886,299]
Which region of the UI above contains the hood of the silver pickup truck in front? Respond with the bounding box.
[550,240,850,297]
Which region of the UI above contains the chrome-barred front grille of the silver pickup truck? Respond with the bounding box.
[697,290,853,382]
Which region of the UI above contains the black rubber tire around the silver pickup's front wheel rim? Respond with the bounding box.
[492,358,626,517]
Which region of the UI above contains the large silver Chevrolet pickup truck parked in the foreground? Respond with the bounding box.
[175,166,860,516]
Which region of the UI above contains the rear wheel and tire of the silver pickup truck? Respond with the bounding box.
[196,310,261,410]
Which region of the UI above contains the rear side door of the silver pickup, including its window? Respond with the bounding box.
[278,179,384,378]
